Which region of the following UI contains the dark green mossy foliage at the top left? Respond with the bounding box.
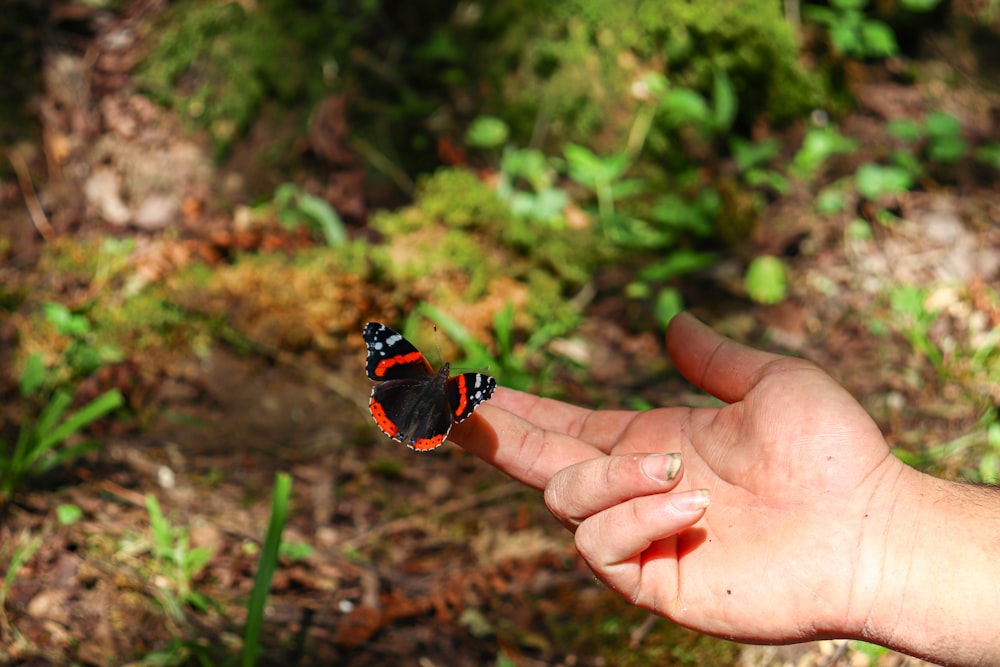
[137,0,380,155]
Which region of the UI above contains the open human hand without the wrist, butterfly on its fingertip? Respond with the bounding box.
[452,315,918,643]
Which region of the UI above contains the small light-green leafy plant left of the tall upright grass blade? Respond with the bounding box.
[146,494,212,620]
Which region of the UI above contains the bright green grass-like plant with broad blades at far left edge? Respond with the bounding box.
[0,354,123,507]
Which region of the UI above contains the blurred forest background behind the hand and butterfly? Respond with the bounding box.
[0,0,1000,667]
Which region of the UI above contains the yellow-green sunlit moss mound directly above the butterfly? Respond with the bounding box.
[370,169,601,340]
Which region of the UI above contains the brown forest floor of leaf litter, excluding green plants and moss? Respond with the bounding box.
[0,2,1000,667]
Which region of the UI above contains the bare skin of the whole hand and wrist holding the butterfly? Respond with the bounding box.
[451,314,1000,665]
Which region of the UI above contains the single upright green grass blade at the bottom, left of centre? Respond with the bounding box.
[241,473,292,667]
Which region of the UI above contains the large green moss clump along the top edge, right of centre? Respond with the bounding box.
[487,0,820,149]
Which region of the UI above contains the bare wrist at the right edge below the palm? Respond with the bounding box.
[858,466,1000,665]
